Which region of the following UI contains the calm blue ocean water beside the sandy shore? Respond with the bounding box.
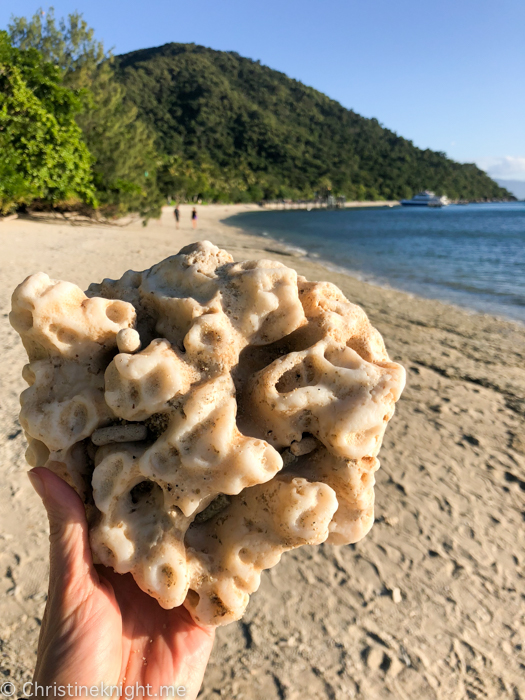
[226,202,525,323]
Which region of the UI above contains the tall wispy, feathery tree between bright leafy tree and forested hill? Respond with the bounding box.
[9,8,163,218]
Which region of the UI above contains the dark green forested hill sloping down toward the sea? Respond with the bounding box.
[114,44,512,201]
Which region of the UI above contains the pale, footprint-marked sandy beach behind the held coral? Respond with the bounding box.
[0,205,525,700]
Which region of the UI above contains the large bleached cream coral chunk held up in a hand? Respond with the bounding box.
[10,241,405,625]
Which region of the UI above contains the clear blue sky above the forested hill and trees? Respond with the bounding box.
[4,0,525,180]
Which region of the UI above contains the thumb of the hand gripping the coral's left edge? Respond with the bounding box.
[28,467,98,594]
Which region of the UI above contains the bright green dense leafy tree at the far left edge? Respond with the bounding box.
[0,31,97,214]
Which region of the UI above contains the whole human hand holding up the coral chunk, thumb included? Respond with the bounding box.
[29,467,214,699]
